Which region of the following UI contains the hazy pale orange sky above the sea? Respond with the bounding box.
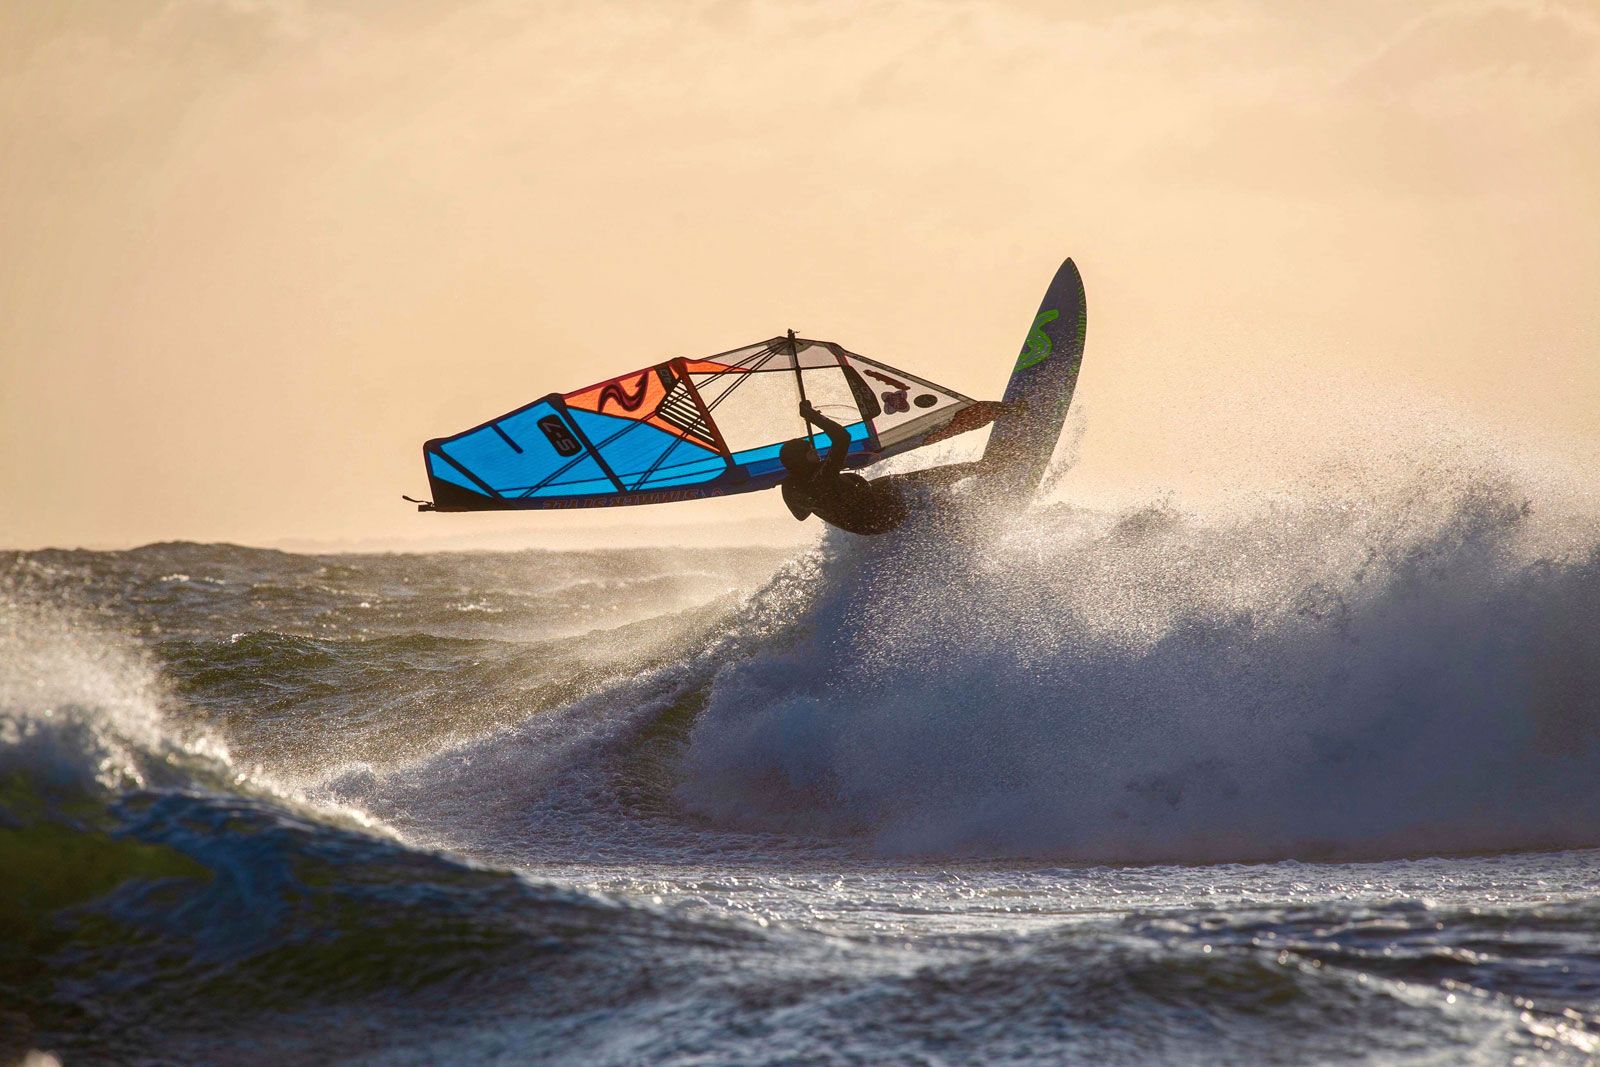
[0,0,1600,547]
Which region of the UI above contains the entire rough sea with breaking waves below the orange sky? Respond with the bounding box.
[0,472,1600,1067]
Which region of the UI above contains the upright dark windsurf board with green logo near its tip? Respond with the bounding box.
[978,259,1088,502]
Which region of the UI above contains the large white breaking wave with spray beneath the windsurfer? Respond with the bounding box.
[677,454,1600,861]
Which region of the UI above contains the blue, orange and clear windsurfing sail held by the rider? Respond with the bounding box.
[422,334,992,512]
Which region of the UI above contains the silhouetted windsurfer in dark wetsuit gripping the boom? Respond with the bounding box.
[778,400,907,534]
